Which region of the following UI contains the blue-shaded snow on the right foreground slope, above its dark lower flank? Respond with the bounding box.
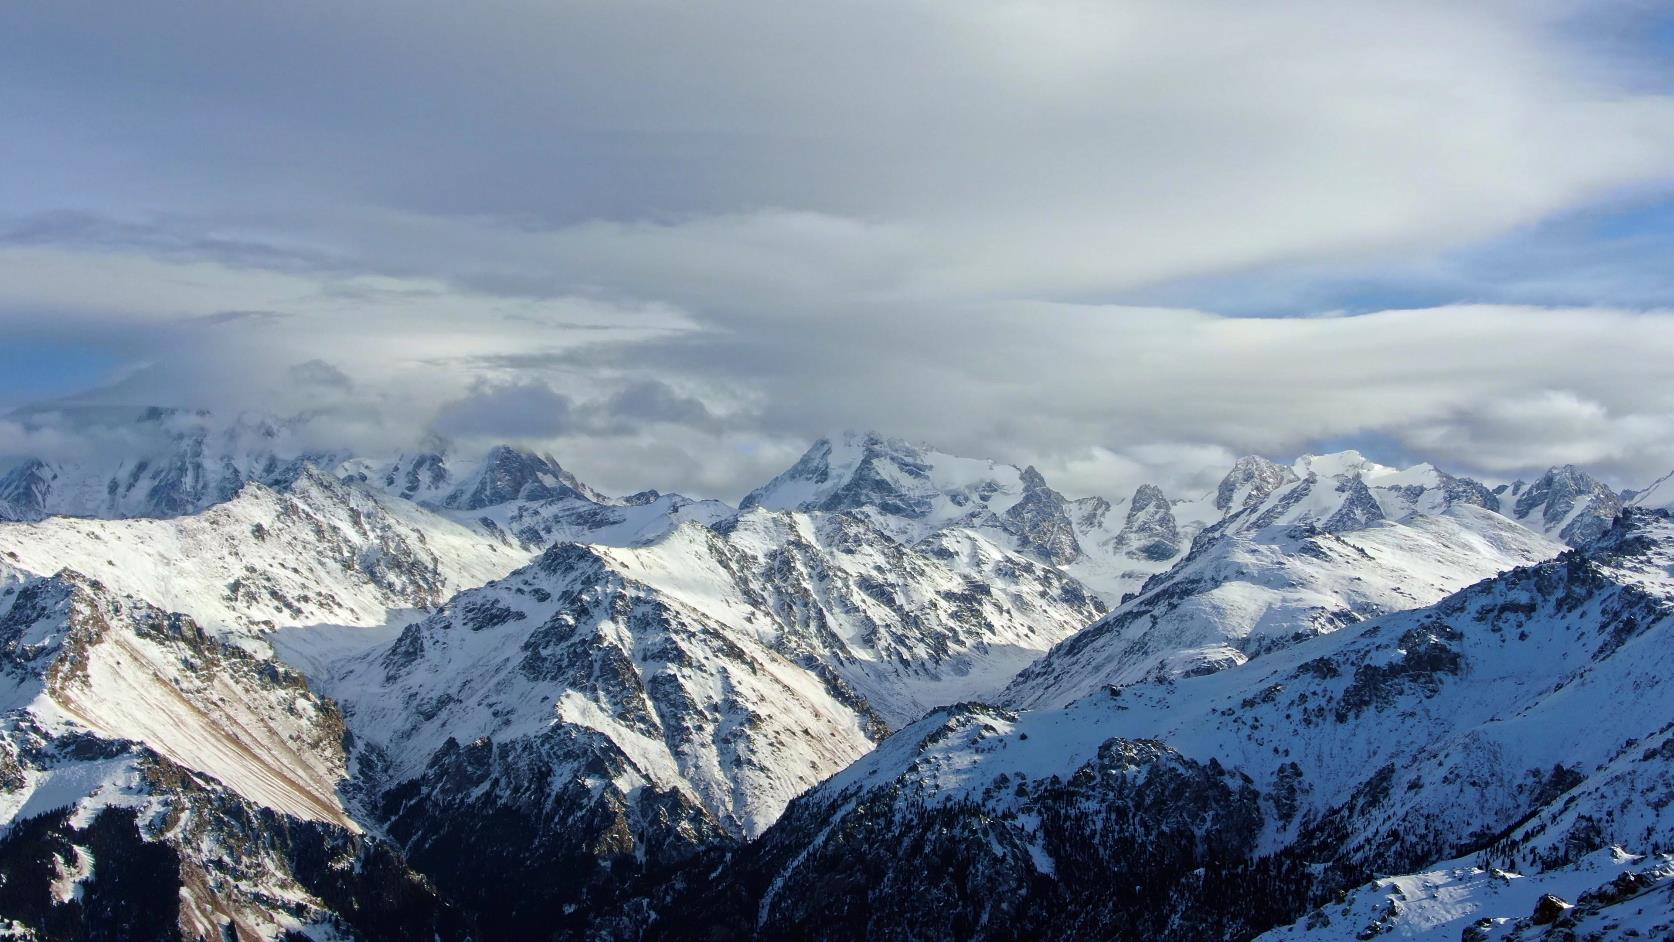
[780,515,1674,939]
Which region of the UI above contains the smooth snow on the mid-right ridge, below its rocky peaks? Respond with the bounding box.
[1003,501,1562,706]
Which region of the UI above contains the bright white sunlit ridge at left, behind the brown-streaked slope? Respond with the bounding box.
[0,467,529,637]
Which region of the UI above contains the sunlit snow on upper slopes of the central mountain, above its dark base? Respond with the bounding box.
[311,510,1093,835]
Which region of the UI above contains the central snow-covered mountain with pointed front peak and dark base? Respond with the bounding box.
[294,509,1101,925]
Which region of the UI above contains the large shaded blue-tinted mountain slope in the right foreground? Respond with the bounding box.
[651,512,1674,939]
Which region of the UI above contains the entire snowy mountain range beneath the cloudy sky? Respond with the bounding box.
[0,410,1674,940]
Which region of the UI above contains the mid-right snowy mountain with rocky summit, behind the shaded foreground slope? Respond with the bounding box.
[1003,452,1562,706]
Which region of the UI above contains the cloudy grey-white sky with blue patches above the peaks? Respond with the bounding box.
[0,0,1674,499]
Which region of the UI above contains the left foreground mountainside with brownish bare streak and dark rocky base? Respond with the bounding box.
[0,574,470,939]
